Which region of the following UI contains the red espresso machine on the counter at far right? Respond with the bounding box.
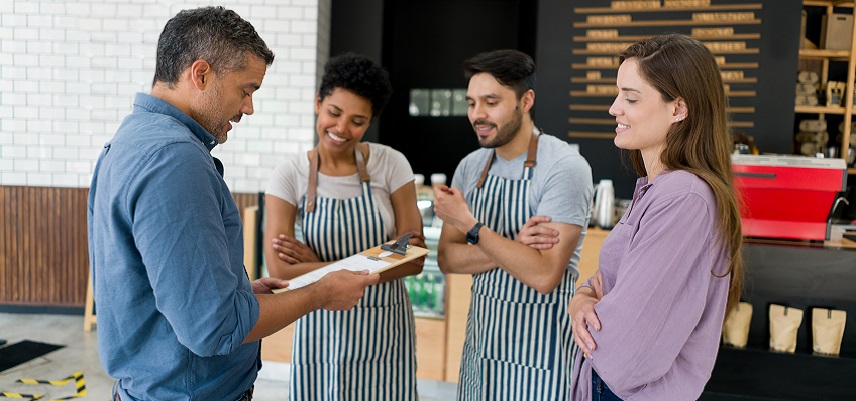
[731,154,847,241]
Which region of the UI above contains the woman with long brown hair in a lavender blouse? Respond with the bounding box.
[568,35,743,400]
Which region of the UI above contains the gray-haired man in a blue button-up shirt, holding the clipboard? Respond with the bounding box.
[88,7,378,401]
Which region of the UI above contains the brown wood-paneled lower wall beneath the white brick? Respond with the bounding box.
[0,186,259,307]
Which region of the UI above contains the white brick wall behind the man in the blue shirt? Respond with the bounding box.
[0,0,331,192]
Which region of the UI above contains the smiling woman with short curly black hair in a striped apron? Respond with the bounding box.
[264,54,425,401]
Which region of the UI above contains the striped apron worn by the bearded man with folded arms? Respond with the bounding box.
[458,132,576,401]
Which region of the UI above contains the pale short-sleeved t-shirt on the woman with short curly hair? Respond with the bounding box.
[265,142,413,238]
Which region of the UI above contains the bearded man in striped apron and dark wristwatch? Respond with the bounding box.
[434,50,593,401]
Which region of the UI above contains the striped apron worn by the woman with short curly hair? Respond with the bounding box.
[289,150,417,401]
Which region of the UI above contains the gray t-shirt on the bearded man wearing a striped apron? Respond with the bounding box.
[452,131,594,274]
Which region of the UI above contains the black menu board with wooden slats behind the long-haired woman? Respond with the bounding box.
[536,0,801,197]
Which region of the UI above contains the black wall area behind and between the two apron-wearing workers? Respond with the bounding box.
[380,0,535,178]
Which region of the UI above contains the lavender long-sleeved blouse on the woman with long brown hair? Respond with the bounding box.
[571,170,730,400]
